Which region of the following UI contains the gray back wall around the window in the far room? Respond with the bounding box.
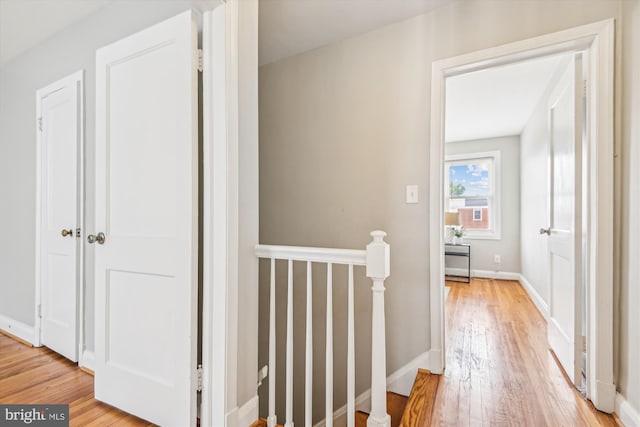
[445,136,520,273]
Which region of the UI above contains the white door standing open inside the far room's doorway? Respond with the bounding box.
[541,54,583,386]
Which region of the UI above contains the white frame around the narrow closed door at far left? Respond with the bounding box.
[33,70,84,366]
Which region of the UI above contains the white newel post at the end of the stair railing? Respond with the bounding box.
[367,231,391,427]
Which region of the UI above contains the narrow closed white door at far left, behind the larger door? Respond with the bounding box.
[36,72,82,362]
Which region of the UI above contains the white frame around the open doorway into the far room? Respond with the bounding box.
[429,19,616,413]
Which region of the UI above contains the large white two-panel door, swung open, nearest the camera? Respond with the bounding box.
[94,11,198,426]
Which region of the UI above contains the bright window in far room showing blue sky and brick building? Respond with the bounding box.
[444,151,500,239]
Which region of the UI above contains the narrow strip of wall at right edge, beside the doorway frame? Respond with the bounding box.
[614,0,640,412]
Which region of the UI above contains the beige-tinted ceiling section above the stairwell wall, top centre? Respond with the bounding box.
[259,0,453,65]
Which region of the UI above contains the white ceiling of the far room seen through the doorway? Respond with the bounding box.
[445,56,564,142]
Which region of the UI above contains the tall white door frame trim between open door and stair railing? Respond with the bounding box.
[200,1,239,426]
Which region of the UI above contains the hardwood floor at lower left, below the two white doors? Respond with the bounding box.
[0,334,153,426]
